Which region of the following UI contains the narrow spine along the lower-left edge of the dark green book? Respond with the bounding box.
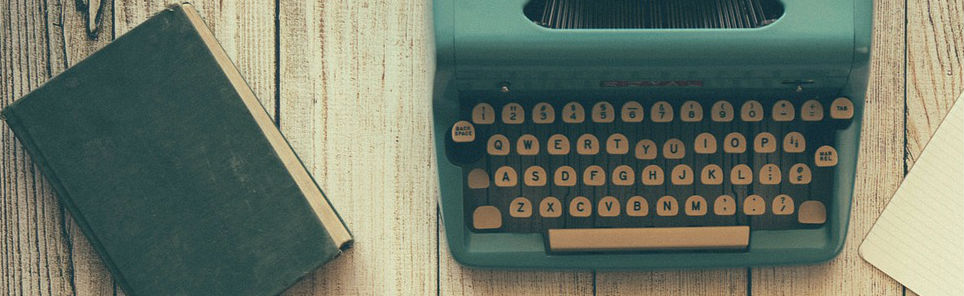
[0,109,136,296]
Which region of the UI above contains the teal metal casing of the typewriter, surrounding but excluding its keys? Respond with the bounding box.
[433,0,873,269]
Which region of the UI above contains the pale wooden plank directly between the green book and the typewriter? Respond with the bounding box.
[279,0,438,295]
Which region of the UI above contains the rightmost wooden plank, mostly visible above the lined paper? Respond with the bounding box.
[904,0,964,296]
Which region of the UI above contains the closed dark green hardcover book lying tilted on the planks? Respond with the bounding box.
[3,4,351,295]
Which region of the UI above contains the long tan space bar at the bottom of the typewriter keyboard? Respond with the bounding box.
[548,226,750,252]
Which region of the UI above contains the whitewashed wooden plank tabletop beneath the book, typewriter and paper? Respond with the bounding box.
[0,0,964,295]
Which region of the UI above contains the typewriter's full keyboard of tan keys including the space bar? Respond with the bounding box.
[447,98,854,252]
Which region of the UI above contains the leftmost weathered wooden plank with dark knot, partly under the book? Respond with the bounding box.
[0,1,114,295]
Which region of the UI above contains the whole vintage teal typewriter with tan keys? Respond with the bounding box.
[433,0,873,269]
